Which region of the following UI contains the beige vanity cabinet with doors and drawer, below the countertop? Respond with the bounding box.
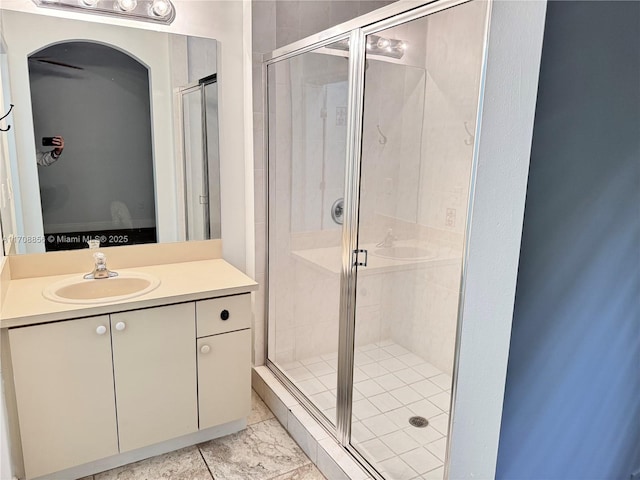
[9,294,251,479]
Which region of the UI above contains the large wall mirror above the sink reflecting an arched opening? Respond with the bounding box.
[0,10,220,254]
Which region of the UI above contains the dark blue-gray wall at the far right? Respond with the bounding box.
[496,1,640,480]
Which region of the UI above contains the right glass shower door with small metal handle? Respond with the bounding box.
[351,2,486,480]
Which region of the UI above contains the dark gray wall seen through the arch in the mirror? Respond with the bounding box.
[29,42,155,233]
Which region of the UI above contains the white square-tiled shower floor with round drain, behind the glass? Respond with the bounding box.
[282,340,451,480]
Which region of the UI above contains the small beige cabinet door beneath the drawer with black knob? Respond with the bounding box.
[198,330,251,428]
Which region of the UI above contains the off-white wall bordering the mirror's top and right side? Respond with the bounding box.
[0,0,254,480]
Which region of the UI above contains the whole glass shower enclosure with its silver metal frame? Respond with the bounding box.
[265,0,490,479]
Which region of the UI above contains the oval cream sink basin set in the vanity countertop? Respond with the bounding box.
[42,272,160,304]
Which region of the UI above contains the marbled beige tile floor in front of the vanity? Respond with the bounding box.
[82,391,326,480]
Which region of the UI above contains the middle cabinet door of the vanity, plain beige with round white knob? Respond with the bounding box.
[111,303,198,452]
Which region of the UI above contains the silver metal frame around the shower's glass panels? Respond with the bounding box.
[261,0,493,480]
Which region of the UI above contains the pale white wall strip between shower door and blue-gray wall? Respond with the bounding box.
[449,0,546,480]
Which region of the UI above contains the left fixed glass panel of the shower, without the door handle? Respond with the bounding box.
[267,43,349,425]
